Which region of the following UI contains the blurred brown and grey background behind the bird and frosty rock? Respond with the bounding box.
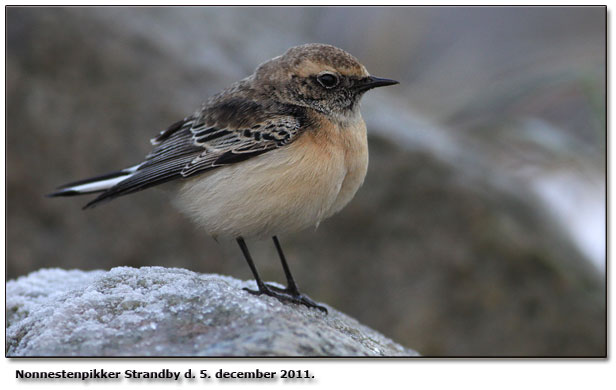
[6,7,606,356]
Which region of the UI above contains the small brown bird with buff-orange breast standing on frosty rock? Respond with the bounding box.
[48,43,398,313]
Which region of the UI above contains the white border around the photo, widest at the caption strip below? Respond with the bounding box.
[0,0,616,390]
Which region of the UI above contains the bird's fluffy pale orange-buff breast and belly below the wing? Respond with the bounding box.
[176,117,368,237]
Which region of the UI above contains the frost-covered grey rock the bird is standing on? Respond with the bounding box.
[6,267,417,356]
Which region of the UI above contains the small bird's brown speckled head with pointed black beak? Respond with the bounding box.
[254,43,398,117]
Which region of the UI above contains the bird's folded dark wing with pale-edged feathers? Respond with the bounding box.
[86,102,302,207]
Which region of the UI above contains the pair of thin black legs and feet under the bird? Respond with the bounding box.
[237,237,327,313]
